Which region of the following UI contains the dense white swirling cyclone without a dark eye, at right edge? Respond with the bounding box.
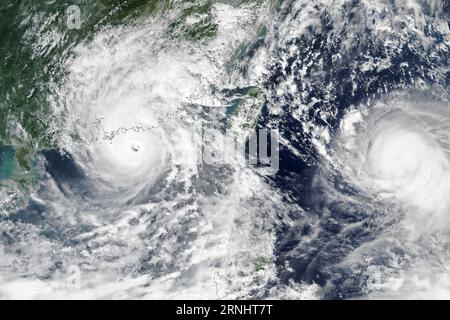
[336,94,450,235]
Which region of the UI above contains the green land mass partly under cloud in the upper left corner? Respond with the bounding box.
[0,0,272,212]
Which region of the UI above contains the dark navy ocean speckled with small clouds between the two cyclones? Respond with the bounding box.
[261,1,450,299]
